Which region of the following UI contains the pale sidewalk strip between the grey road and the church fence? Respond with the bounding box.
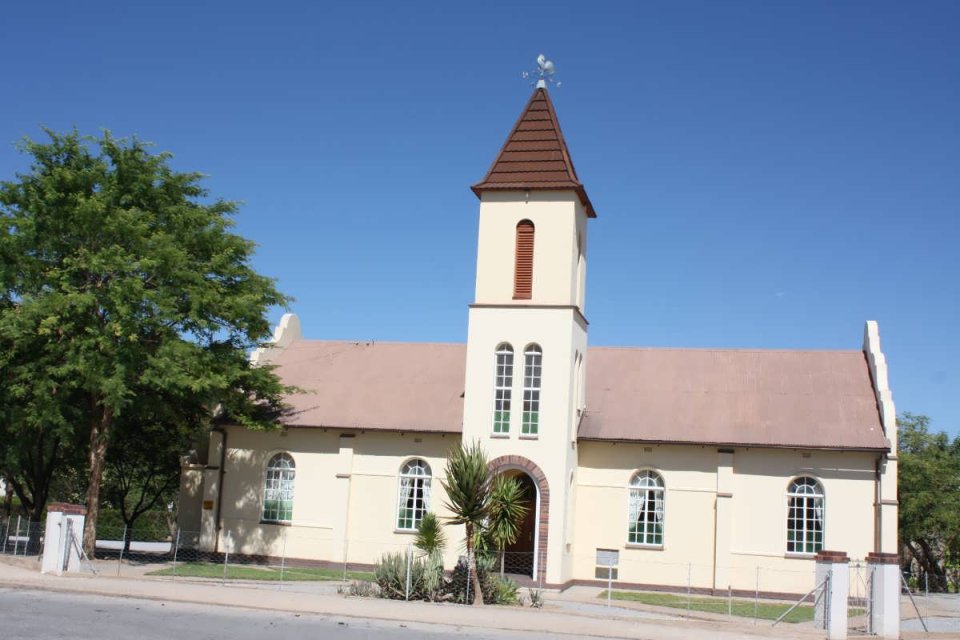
[0,557,823,640]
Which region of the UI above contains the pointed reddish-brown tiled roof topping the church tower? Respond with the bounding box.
[471,88,597,218]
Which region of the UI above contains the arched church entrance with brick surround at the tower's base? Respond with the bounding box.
[490,455,550,581]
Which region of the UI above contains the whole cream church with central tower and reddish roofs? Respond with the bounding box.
[180,81,897,593]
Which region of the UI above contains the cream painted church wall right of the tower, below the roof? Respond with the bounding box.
[573,442,876,593]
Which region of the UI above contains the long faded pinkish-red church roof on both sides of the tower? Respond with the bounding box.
[272,340,889,450]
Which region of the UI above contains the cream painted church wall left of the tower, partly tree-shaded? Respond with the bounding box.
[210,428,463,566]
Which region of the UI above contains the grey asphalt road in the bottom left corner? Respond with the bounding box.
[0,588,572,640]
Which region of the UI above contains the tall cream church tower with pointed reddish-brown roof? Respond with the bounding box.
[463,80,596,584]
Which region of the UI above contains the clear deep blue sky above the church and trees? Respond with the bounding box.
[0,0,960,434]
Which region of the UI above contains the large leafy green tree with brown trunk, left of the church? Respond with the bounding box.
[0,130,287,554]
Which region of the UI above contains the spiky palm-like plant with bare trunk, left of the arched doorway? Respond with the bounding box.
[441,442,492,604]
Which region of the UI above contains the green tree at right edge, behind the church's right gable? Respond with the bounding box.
[897,413,960,589]
